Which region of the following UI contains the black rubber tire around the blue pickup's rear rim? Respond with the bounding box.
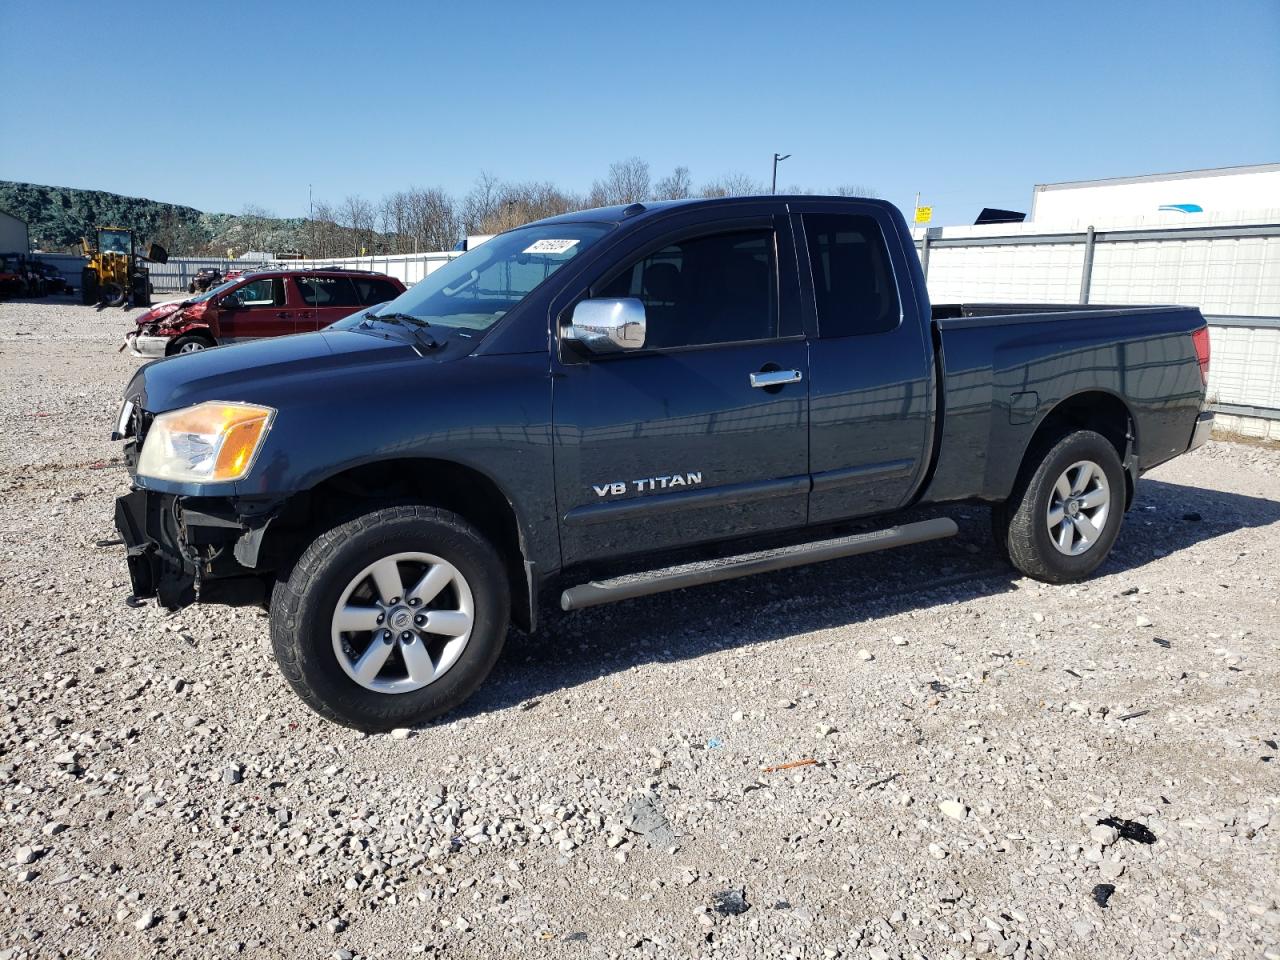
[992,430,1125,584]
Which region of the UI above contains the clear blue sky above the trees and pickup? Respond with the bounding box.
[0,0,1280,224]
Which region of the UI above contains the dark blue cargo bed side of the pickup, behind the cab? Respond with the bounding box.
[925,303,1204,500]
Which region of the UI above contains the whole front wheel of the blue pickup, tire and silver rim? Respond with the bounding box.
[271,507,511,731]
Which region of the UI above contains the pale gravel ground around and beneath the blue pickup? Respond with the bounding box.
[0,301,1280,960]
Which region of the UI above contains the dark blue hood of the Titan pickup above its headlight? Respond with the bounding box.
[125,330,430,413]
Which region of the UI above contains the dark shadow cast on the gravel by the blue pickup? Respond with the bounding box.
[455,480,1280,722]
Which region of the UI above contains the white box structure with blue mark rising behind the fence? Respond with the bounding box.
[1029,164,1280,228]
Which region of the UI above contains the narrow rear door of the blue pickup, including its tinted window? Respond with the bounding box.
[791,202,934,524]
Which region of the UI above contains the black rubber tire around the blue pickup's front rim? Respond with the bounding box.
[271,506,511,731]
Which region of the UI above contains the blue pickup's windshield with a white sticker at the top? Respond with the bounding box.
[369,223,609,330]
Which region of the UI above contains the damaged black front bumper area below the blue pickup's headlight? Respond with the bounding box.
[115,488,274,609]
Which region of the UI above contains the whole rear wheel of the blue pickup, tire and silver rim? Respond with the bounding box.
[993,430,1125,584]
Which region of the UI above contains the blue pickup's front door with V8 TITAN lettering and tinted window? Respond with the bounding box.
[553,216,809,564]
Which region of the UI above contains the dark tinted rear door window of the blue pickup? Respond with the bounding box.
[804,214,902,337]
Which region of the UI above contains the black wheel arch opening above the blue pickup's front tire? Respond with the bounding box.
[262,457,538,631]
